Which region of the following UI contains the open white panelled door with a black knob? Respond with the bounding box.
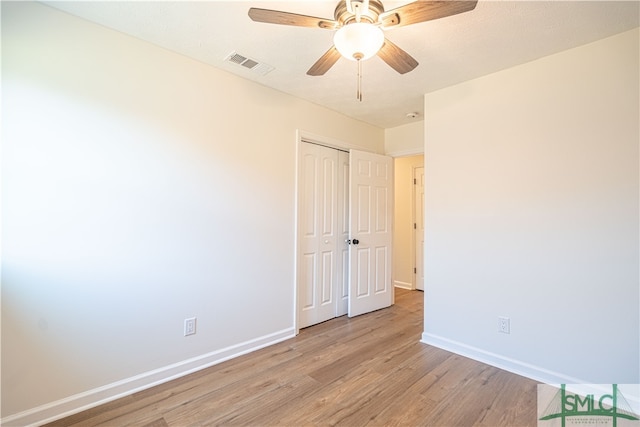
[349,150,393,317]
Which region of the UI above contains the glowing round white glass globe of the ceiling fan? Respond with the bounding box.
[333,22,384,61]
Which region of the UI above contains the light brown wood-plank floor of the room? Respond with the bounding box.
[51,289,537,427]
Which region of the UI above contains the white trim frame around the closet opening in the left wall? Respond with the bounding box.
[293,129,388,335]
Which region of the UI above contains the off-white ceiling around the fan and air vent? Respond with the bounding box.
[44,0,640,128]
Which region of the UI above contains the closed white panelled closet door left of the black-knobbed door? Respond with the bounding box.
[297,143,349,328]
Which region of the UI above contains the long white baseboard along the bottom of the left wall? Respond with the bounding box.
[0,328,295,427]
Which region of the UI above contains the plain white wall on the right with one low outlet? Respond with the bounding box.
[423,29,640,383]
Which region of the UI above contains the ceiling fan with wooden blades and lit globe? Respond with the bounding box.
[249,0,477,77]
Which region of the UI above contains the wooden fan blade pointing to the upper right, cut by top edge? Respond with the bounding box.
[379,0,478,28]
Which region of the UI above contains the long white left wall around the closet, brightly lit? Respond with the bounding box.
[2,2,384,425]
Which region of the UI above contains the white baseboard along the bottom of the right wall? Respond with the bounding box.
[420,332,586,384]
